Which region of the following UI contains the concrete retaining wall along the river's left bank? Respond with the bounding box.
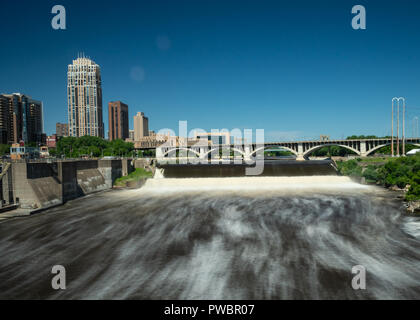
[8,159,134,209]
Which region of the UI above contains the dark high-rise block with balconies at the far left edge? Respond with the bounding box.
[0,93,44,144]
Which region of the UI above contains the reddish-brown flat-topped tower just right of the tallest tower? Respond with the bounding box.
[108,101,129,141]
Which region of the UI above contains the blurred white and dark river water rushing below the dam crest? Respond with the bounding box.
[0,164,420,300]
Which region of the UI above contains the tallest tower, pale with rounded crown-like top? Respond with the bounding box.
[67,57,104,138]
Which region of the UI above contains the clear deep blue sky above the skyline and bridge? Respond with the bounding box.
[0,0,420,140]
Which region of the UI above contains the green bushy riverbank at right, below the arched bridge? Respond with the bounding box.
[336,155,420,215]
